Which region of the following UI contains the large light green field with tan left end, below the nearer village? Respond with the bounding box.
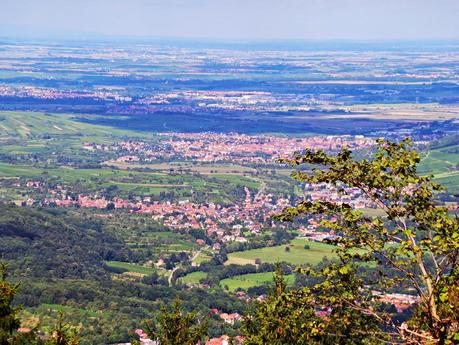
[225,239,335,265]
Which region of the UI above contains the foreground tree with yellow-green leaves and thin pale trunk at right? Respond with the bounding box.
[246,139,459,344]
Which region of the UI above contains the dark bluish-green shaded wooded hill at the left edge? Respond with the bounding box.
[0,205,125,280]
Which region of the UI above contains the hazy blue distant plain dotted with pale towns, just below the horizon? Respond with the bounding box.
[0,44,457,119]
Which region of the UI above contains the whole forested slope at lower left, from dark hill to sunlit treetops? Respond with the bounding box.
[0,204,244,344]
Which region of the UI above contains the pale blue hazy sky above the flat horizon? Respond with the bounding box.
[0,0,459,40]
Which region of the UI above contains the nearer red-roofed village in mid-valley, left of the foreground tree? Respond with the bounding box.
[40,188,289,245]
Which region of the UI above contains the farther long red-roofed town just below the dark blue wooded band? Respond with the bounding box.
[83,132,374,163]
